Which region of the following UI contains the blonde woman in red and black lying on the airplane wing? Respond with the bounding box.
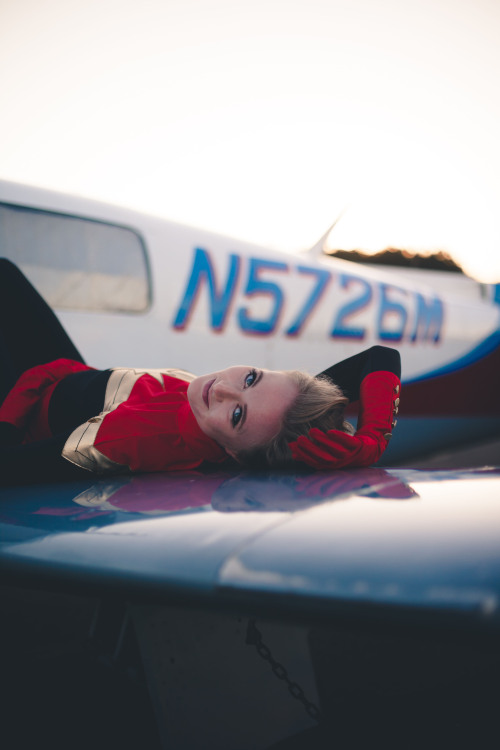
[0,259,401,485]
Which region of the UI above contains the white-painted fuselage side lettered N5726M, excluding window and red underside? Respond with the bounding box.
[0,182,500,380]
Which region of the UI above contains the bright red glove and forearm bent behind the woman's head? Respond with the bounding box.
[290,370,401,469]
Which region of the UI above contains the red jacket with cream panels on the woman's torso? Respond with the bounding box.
[0,359,227,473]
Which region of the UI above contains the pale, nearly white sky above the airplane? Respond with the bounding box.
[0,0,500,282]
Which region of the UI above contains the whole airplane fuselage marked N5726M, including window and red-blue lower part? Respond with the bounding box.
[0,182,500,460]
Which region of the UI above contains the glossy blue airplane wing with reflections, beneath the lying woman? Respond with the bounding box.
[0,467,500,627]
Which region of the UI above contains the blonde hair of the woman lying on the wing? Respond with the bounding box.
[238,370,354,468]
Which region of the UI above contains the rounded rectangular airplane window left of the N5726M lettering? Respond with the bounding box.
[0,203,151,312]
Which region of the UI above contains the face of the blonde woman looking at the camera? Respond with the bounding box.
[187,365,298,456]
